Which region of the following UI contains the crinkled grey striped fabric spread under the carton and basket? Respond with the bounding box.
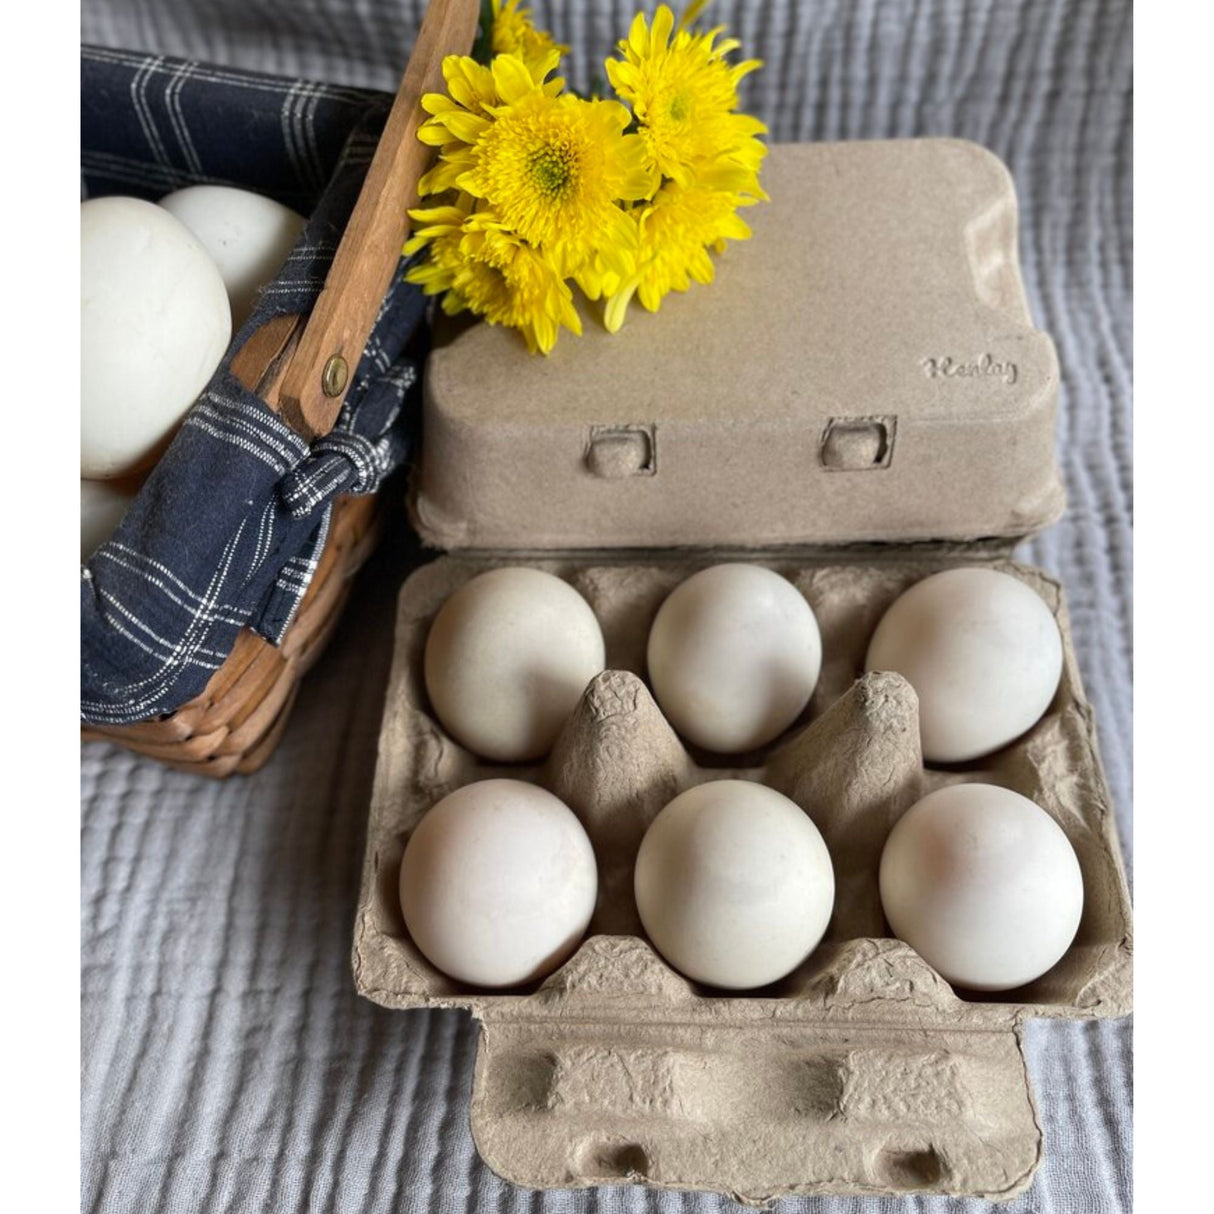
[81,0,1131,1214]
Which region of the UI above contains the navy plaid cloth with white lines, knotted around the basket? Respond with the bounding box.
[80,47,425,725]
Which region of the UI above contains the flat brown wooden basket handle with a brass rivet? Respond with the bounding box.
[239,0,481,442]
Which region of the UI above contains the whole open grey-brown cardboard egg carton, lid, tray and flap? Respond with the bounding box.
[353,140,1130,1203]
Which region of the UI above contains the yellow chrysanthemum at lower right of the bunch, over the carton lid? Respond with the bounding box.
[603,181,755,333]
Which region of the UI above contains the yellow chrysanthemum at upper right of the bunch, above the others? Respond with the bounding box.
[606,5,767,186]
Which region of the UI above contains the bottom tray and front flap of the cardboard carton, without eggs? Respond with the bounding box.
[353,550,1131,1204]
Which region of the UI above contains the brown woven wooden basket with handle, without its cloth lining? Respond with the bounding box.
[81,0,480,777]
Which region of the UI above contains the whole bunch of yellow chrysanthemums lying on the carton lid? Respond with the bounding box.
[404,0,766,353]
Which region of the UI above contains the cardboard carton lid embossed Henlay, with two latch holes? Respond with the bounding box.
[413,138,1063,550]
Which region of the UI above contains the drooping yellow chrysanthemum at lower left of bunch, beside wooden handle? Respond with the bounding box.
[404,198,582,354]
